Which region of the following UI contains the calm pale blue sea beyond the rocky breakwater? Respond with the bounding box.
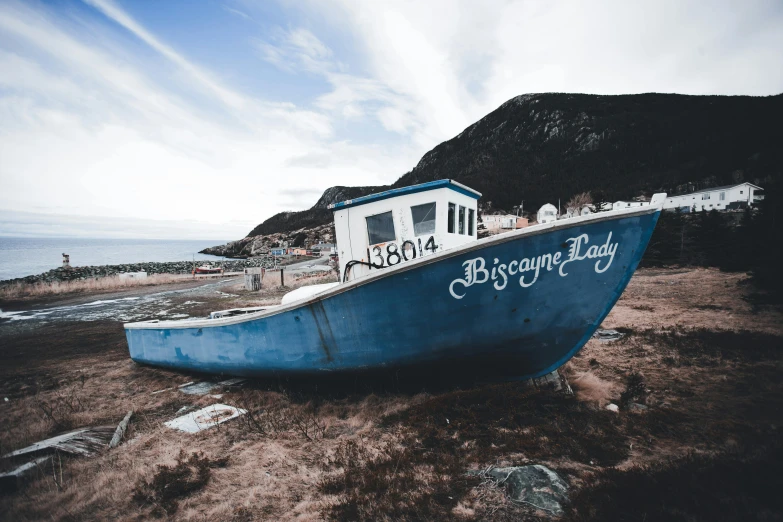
[0,237,227,280]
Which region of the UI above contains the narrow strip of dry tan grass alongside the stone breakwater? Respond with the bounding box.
[0,274,193,300]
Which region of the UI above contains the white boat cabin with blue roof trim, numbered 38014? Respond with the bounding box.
[329,179,481,281]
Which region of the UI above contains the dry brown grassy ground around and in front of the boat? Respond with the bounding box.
[0,269,783,521]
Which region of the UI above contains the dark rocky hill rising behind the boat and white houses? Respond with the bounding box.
[204,93,783,255]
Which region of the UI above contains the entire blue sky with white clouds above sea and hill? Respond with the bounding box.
[0,0,783,239]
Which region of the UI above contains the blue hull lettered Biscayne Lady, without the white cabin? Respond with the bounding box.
[126,211,660,378]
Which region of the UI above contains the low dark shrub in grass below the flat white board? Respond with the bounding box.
[133,444,228,515]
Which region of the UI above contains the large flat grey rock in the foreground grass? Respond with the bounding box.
[485,464,568,516]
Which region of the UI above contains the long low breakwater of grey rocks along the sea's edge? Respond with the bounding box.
[0,257,272,286]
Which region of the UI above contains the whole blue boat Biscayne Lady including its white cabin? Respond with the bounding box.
[125,180,665,379]
